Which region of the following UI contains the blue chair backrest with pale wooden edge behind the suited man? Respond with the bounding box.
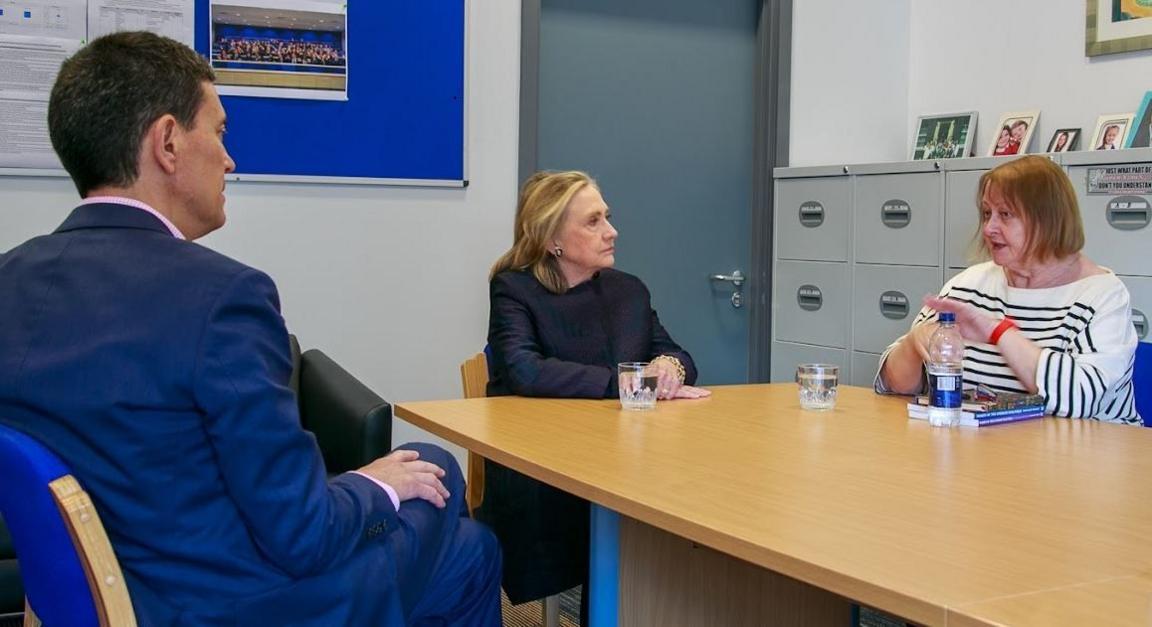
[0,425,136,627]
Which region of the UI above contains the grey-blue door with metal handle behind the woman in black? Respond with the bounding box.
[522,0,760,384]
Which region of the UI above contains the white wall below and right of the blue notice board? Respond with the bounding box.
[0,0,520,465]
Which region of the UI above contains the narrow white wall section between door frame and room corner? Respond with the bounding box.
[789,0,912,166]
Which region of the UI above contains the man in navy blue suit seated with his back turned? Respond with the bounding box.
[0,32,500,626]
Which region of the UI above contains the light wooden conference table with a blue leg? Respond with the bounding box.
[396,384,1152,627]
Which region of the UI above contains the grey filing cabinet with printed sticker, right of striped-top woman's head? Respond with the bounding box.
[1063,149,1152,342]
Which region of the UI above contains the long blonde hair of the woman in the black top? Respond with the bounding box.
[488,171,597,294]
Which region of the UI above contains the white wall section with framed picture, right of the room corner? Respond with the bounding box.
[908,0,1152,154]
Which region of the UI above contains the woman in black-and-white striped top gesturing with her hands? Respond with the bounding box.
[876,157,1140,424]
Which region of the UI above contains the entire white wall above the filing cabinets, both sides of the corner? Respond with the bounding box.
[790,0,1152,166]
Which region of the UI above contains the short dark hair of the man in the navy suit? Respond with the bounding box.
[48,32,215,196]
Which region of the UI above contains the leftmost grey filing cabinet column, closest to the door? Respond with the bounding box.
[771,166,852,382]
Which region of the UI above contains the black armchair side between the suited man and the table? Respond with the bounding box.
[300,348,392,475]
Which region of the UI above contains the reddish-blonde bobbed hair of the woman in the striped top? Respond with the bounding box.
[976,154,1084,262]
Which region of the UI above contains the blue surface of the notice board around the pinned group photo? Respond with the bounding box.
[196,0,467,186]
